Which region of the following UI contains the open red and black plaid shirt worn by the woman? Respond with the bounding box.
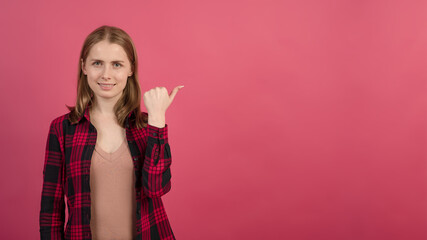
[39,103,175,240]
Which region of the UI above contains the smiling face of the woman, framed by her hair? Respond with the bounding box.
[81,40,132,101]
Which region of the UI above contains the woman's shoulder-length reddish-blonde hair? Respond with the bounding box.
[65,25,148,128]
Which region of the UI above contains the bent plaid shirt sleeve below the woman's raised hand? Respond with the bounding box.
[142,124,172,198]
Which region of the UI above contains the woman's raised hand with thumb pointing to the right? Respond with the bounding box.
[143,86,184,128]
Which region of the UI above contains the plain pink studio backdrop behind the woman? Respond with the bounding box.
[0,0,427,240]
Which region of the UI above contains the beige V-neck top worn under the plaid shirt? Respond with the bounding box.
[90,140,136,240]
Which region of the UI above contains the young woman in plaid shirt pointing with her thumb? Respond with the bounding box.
[39,26,183,240]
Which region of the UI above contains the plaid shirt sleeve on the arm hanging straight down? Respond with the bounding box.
[39,121,65,240]
